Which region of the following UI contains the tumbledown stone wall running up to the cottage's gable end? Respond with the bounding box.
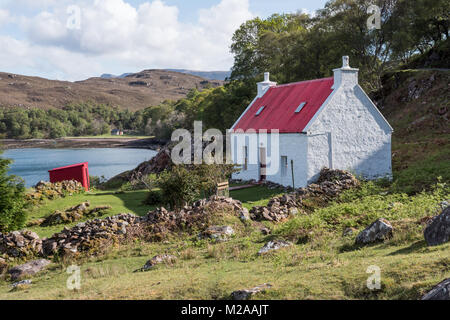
[250,168,359,222]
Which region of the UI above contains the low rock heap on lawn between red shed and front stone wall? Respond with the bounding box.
[41,202,111,227]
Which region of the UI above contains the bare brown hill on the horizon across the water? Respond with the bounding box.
[0,70,223,110]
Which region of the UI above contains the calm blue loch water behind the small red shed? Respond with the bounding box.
[3,148,156,187]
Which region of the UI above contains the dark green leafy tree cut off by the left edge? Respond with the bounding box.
[0,150,26,232]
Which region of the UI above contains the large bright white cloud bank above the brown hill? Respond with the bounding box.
[0,0,253,80]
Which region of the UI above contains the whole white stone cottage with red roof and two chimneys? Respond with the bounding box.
[230,57,393,188]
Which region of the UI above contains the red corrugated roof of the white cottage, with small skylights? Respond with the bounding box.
[233,78,334,133]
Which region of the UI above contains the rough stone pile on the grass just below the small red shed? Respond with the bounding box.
[27,180,85,202]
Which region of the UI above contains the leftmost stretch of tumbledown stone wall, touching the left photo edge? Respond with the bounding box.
[0,230,42,259]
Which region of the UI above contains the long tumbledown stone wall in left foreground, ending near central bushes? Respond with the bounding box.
[42,213,140,256]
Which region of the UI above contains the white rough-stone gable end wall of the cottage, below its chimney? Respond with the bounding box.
[307,83,392,182]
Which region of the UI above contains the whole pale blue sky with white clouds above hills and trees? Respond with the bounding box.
[0,0,326,81]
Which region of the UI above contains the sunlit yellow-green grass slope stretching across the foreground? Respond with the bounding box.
[0,224,450,299]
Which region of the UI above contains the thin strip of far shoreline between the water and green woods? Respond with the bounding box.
[0,137,166,151]
